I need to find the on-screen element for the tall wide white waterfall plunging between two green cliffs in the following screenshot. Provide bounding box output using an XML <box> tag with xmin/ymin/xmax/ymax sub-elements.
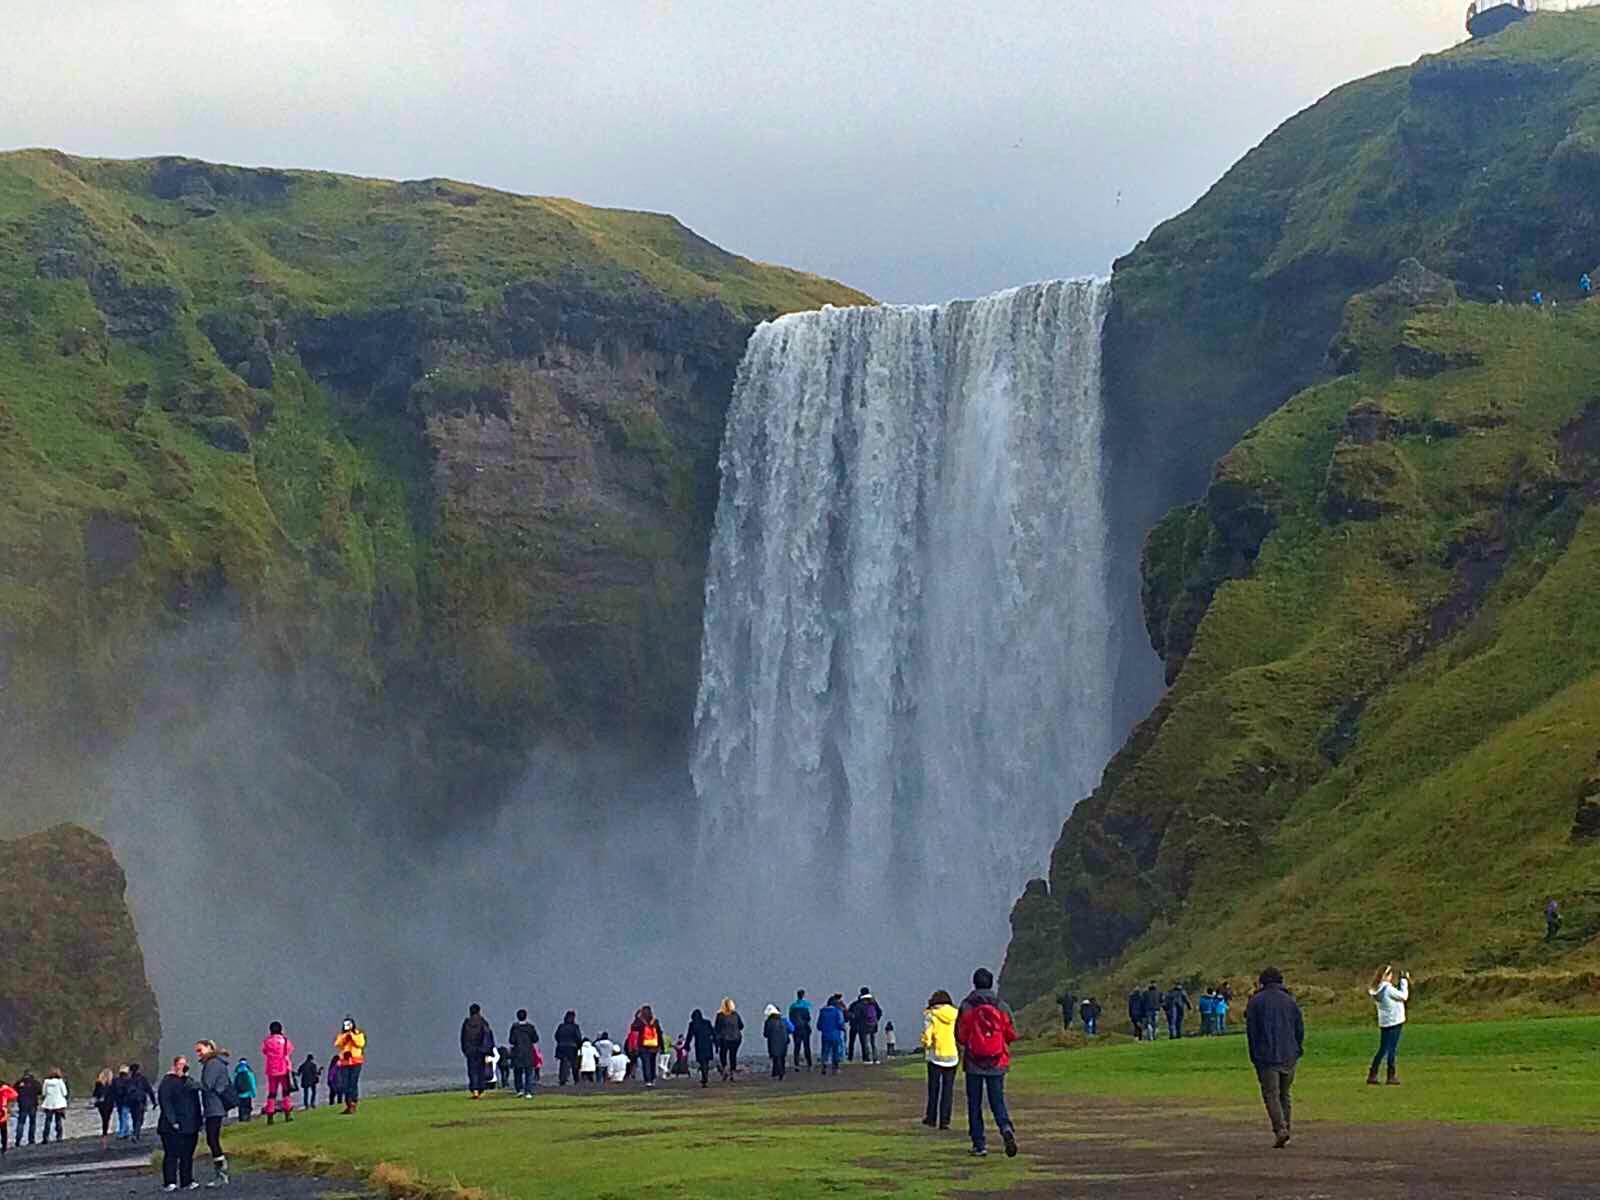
<box><xmin>693</xmin><ymin>280</ymin><xmax>1114</xmax><ymax>1005</ymax></box>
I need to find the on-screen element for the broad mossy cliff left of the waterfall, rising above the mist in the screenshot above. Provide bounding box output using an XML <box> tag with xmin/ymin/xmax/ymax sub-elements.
<box><xmin>0</xmin><ymin>150</ymin><xmax>864</xmax><ymax>824</ymax></box>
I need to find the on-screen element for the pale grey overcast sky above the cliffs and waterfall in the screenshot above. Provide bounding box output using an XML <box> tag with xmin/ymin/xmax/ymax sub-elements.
<box><xmin>0</xmin><ymin>0</ymin><xmax>1466</xmax><ymax>301</ymax></box>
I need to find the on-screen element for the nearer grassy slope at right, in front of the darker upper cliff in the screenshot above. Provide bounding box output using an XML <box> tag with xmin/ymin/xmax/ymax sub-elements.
<box><xmin>1006</xmin><ymin>264</ymin><xmax>1600</xmax><ymax>1010</ymax></box>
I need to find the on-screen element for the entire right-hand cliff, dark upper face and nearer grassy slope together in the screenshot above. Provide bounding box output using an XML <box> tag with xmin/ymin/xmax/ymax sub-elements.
<box><xmin>1006</xmin><ymin>13</ymin><xmax>1600</xmax><ymax>998</ymax></box>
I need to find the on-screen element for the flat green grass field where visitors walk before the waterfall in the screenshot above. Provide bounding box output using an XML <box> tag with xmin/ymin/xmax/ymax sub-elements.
<box><xmin>229</xmin><ymin>1018</ymin><xmax>1600</xmax><ymax>1200</ymax></box>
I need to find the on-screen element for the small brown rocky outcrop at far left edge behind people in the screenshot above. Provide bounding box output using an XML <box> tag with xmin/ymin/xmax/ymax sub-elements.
<box><xmin>0</xmin><ymin>826</ymin><xmax>162</xmax><ymax>1091</ymax></box>
